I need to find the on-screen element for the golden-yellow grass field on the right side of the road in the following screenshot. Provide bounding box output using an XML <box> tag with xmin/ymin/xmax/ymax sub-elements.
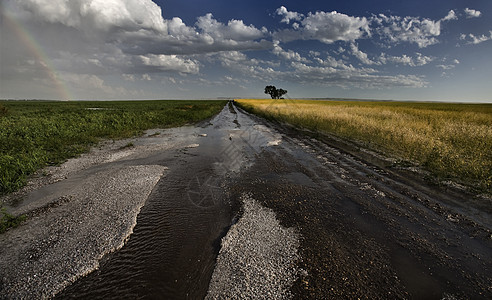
<box><xmin>236</xmin><ymin>99</ymin><xmax>492</xmax><ymax>193</ymax></box>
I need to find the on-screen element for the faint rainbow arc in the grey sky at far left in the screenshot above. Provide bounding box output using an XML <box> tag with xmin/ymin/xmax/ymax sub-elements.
<box><xmin>3</xmin><ymin>13</ymin><xmax>73</xmax><ymax>100</ymax></box>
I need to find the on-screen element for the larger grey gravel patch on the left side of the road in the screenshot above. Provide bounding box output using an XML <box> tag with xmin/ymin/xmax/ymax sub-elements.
<box><xmin>0</xmin><ymin>165</ymin><xmax>166</xmax><ymax>299</ymax></box>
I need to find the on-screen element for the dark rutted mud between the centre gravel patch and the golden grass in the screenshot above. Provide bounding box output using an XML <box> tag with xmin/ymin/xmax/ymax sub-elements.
<box><xmin>230</xmin><ymin>105</ymin><xmax>492</xmax><ymax>299</ymax></box>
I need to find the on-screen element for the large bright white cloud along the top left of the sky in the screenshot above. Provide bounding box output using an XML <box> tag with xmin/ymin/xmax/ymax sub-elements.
<box><xmin>7</xmin><ymin>0</ymin><xmax>272</xmax><ymax>55</ymax></box>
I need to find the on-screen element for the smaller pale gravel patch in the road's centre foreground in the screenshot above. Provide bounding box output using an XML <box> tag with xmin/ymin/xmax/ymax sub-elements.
<box><xmin>206</xmin><ymin>194</ymin><xmax>299</xmax><ymax>299</ymax></box>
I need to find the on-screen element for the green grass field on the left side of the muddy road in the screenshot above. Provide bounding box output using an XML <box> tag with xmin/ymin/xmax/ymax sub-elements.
<box><xmin>0</xmin><ymin>101</ymin><xmax>226</xmax><ymax>194</ymax></box>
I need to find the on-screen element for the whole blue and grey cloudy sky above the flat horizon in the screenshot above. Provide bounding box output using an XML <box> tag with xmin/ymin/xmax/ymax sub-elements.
<box><xmin>0</xmin><ymin>0</ymin><xmax>492</xmax><ymax>103</ymax></box>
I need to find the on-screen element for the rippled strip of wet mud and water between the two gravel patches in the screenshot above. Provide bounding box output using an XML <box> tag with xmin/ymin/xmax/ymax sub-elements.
<box><xmin>56</xmin><ymin>103</ymin><xmax>282</xmax><ymax>299</ymax></box>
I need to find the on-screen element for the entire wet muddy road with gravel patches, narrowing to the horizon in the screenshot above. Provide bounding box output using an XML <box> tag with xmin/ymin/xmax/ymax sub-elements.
<box><xmin>0</xmin><ymin>103</ymin><xmax>492</xmax><ymax>299</ymax></box>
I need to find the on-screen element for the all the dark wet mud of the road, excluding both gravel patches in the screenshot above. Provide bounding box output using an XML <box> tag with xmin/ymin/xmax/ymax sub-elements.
<box><xmin>0</xmin><ymin>103</ymin><xmax>492</xmax><ymax>299</ymax></box>
